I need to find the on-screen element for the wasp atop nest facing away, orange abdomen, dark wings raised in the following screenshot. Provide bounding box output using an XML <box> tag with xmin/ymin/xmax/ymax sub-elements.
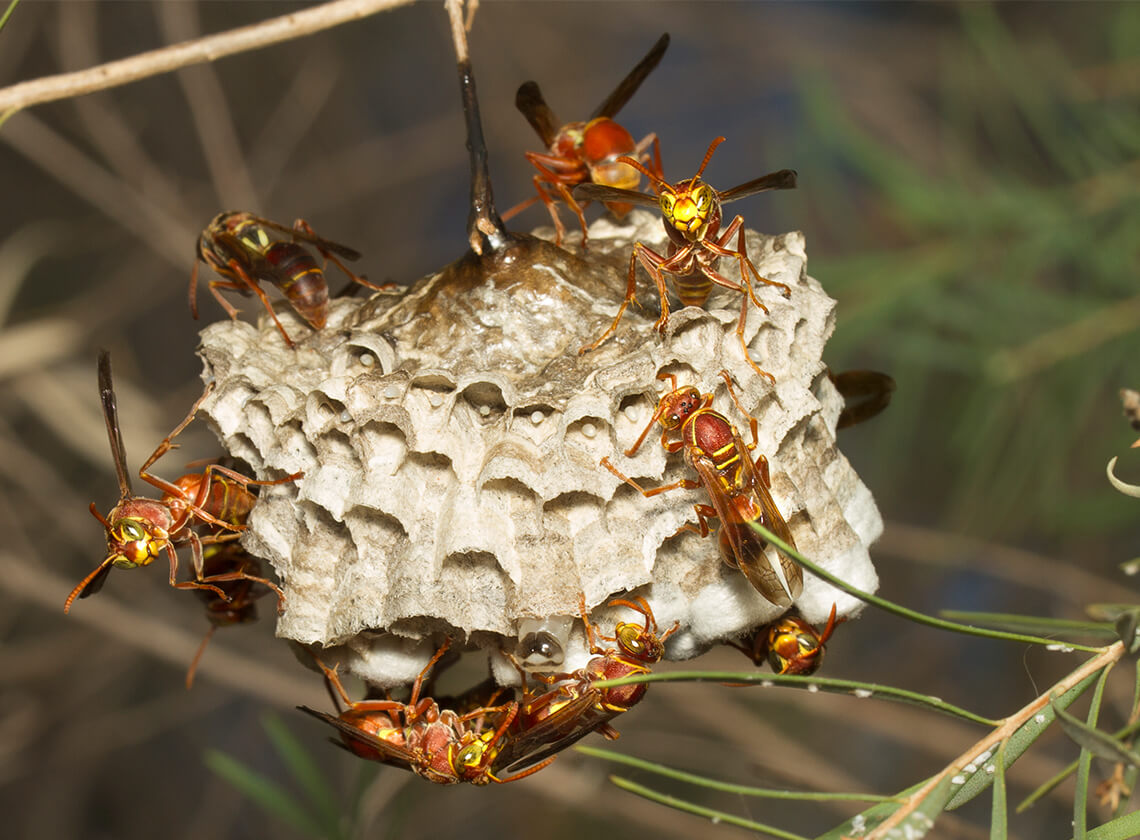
<box><xmin>503</xmin><ymin>34</ymin><xmax>669</xmax><ymax>248</ymax></box>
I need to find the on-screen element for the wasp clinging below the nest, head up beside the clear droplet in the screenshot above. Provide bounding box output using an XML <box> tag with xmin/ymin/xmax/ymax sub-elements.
<box><xmin>495</xmin><ymin>598</ymin><xmax>678</xmax><ymax>772</ymax></box>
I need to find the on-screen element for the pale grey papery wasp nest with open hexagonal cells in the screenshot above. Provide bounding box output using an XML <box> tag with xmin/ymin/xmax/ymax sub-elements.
<box><xmin>201</xmin><ymin>211</ymin><xmax>882</xmax><ymax>685</ymax></box>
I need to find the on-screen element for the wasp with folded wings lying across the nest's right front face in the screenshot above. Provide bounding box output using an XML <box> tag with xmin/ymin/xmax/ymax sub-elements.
<box><xmin>602</xmin><ymin>370</ymin><xmax>804</xmax><ymax>606</ymax></box>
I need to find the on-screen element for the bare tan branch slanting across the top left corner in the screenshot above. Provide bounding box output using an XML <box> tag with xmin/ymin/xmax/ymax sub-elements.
<box><xmin>0</xmin><ymin>0</ymin><xmax>412</xmax><ymax>114</ymax></box>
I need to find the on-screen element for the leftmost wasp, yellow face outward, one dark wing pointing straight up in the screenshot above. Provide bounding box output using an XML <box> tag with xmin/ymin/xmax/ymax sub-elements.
<box><xmin>64</xmin><ymin>351</ymin><xmax>301</xmax><ymax>612</ymax></box>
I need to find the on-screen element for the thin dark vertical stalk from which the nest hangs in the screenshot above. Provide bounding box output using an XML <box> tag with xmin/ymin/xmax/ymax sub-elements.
<box><xmin>446</xmin><ymin>0</ymin><xmax>511</xmax><ymax>255</ymax></box>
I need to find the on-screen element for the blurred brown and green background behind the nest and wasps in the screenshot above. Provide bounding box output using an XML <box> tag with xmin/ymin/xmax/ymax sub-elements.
<box><xmin>0</xmin><ymin>2</ymin><xmax>1140</xmax><ymax>840</ymax></box>
